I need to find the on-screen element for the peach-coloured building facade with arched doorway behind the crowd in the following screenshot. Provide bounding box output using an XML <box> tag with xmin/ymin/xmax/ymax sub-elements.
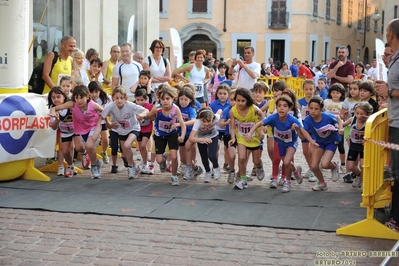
<box><xmin>159</xmin><ymin>0</ymin><xmax>393</xmax><ymax>67</ymax></box>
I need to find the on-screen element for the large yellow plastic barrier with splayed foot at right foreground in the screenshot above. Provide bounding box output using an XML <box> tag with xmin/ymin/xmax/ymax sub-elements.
<box><xmin>336</xmin><ymin>109</ymin><xmax>399</xmax><ymax>240</ymax></box>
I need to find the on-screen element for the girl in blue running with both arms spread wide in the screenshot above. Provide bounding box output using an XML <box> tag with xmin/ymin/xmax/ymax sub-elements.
<box><xmin>245</xmin><ymin>95</ymin><xmax>317</xmax><ymax>193</ymax></box>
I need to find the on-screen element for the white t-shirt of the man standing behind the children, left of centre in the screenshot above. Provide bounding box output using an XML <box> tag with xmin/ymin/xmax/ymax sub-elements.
<box><xmin>112</xmin><ymin>61</ymin><xmax>143</xmax><ymax>100</ymax></box>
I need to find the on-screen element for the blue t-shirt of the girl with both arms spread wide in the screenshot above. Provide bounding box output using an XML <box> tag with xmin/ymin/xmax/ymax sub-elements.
<box><xmin>262</xmin><ymin>113</ymin><xmax>302</xmax><ymax>147</ymax></box>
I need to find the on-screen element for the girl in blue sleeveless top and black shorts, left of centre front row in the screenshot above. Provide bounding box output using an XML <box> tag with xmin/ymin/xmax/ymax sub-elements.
<box><xmin>146</xmin><ymin>83</ymin><xmax>186</xmax><ymax>186</ymax></box>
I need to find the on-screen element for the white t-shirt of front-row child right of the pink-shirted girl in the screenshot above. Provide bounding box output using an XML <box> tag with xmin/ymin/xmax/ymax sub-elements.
<box><xmin>101</xmin><ymin>101</ymin><xmax>146</xmax><ymax>136</ymax></box>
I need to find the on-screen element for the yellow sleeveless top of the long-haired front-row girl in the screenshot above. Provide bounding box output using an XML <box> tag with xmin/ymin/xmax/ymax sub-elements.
<box><xmin>231</xmin><ymin>105</ymin><xmax>260</xmax><ymax>148</ymax></box>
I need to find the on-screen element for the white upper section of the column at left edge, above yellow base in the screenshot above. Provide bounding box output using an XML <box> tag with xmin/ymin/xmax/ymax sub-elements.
<box><xmin>0</xmin><ymin>0</ymin><xmax>31</xmax><ymax>89</ymax></box>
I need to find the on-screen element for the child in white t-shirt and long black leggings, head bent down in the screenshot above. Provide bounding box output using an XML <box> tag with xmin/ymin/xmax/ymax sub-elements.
<box><xmin>188</xmin><ymin>107</ymin><xmax>222</xmax><ymax>183</ymax></box>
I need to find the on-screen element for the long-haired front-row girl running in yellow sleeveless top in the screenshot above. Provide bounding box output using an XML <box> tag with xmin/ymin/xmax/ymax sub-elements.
<box><xmin>229</xmin><ymin>88</ymin><xmax>265</xmax><ymax>189</ymax></box>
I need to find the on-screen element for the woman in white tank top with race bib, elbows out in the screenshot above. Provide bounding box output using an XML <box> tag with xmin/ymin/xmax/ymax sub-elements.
<box><xmin>172</xmin><ymin>50</ymin><xmax>211</xmax><ymax>107</ymax></box>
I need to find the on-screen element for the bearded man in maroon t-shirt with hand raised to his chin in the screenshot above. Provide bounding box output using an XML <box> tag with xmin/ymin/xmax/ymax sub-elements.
<box><xmin>327</xmin><ymin>46</ymin><xmax>355</xmax><ymax>88</ymax></box>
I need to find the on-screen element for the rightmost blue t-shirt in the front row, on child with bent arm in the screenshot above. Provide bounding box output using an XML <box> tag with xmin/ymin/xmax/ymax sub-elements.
<box><xmin>303</xmin><ymin>112</ymin><xmax>341</xmax><ymax>144</ymax></box>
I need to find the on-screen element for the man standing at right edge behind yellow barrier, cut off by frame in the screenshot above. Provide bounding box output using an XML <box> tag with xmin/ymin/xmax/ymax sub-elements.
<box><xmin>375</xmin><ymin>19</ymin><xmax>399</xmax><ymax>232</ymax></box>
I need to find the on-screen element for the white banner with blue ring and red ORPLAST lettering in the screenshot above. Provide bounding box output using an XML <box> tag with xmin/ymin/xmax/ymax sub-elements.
<box><xmin>0</xmin><ymin>93</ymin><xmax>56</xmax><ymax>163</ymax></box>
